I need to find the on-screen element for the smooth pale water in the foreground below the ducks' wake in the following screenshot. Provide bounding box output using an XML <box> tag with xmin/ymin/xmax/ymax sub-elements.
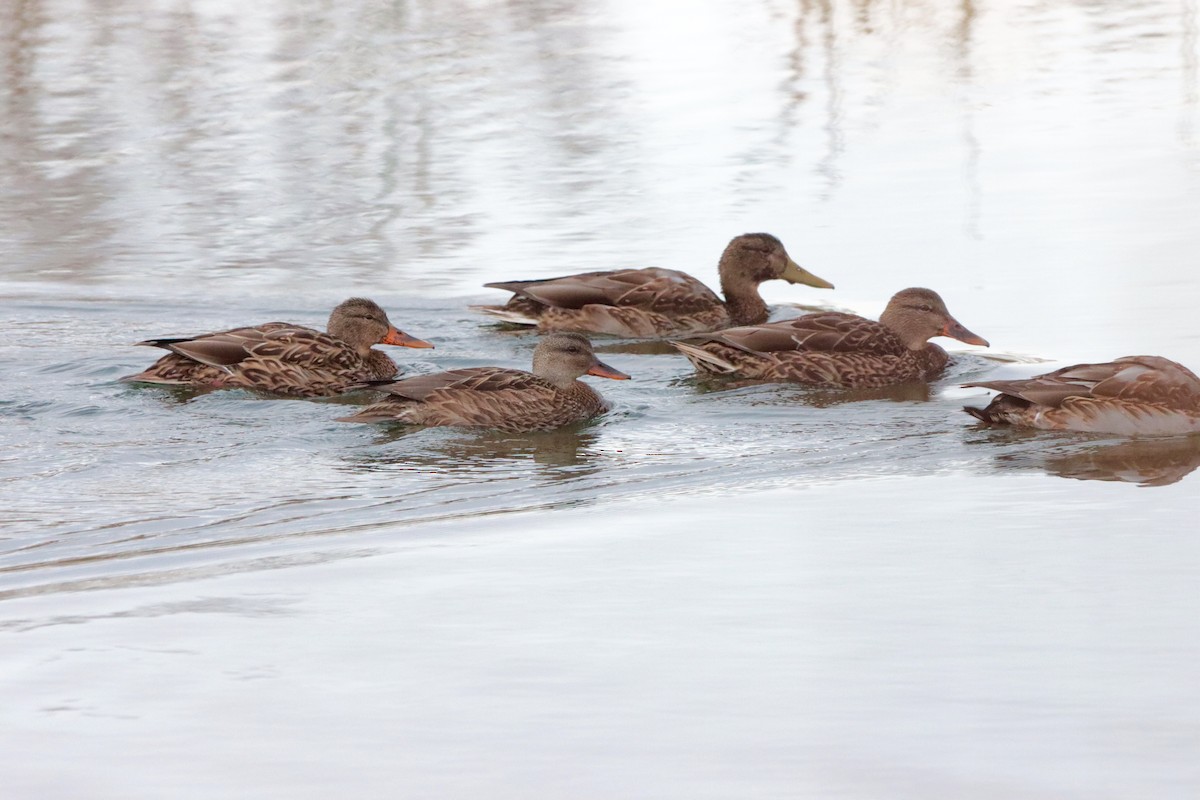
<box><xmin>7</xmin><ymin>477</ymin><xmax>1200</xmax><ymax>800</ymax></box>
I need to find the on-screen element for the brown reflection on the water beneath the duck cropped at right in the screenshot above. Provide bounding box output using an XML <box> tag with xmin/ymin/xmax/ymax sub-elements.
<box><xmin>968</xmin><ymin>429</ymin><xmax>1200</xmax><ymax>486</ymax></box>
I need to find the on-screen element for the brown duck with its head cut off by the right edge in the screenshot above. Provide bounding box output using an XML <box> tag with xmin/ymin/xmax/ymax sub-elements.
<box><xmin>962</xmin><ymin>355</ymin><xmax>1200</xmax><ymax>437</ymax></box>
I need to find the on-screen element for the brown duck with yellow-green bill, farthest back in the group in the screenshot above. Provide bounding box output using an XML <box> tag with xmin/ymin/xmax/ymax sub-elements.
<box><xmin>475</xmin><ymin>233</ymin><xmax>833</xmax><ymax>338</ymax></box>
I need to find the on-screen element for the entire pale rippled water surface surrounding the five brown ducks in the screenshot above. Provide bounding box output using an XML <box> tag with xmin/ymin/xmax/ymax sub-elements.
<box><xmin>0</xmin><ymin>0</ymin><xmax>1200</xmax><ymax>800</ymax></box>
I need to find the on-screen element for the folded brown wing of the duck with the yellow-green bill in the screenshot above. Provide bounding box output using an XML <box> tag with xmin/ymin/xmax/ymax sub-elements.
<box><xmin>485</xmin><ymin>267</ymin><xmax>721</xmax><ymax>312</ymax></box>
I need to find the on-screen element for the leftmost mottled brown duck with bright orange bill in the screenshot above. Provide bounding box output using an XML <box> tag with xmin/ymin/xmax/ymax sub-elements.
<box><xmin>121</xmin><ymin>297</ymin><xmax>433</xmax><ymax>397</ymax></box>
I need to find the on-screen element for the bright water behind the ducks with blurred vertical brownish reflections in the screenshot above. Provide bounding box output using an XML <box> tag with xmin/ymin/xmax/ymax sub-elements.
<box><xmin>7</xmin><ymin>0</ymin><xmax>1198</xmax><ymax>360</ymax></box>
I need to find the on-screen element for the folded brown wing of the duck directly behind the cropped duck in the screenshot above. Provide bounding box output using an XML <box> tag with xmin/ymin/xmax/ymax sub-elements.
<box><xmin>701</xmin><ymin>312</ymin><xmax>905</xmax><ymax>356</ymax></box>
